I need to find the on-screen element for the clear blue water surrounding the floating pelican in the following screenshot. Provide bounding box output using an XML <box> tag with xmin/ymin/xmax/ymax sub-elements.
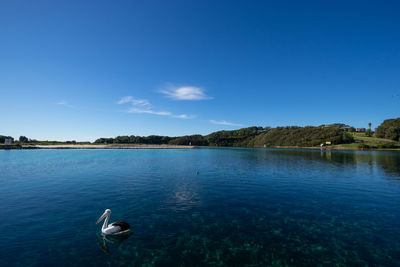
<box><xmin>0</xmin><ymin>148</ymin><xmax>400</xmax><ymax>266</ymax></box>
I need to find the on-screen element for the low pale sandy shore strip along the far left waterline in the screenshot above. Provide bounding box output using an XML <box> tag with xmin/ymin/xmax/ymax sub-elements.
<box><xmin>22</xmin><ymin>144</ymin><xmax>195</xmax><ymax>149</ymax></box>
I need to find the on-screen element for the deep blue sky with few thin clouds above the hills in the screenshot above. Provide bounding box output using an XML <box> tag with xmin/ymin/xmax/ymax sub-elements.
<box><xmin>0</xmin><ymin>0</ymin><xmax>400</xmax><ymax>141</ymax></box>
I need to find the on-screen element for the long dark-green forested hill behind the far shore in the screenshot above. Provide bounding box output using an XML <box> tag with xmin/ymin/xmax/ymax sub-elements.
<box><xmin>95</xmin><ymin>126</ymin><xmax>354</xmax><ymax>147</ymax></box>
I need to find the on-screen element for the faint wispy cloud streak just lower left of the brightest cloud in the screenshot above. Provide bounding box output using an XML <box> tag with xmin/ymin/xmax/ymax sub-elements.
<box><xmin>117</xmin><ymin>96</ymin><xmax>195</xmax><ymax>119</ymax></box>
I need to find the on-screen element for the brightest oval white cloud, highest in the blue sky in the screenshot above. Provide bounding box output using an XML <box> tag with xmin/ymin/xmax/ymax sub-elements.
<box><xmin>160</xmin><ymin>86</ymin><xmax>212</xmax><ymax>100</ymax></box>
